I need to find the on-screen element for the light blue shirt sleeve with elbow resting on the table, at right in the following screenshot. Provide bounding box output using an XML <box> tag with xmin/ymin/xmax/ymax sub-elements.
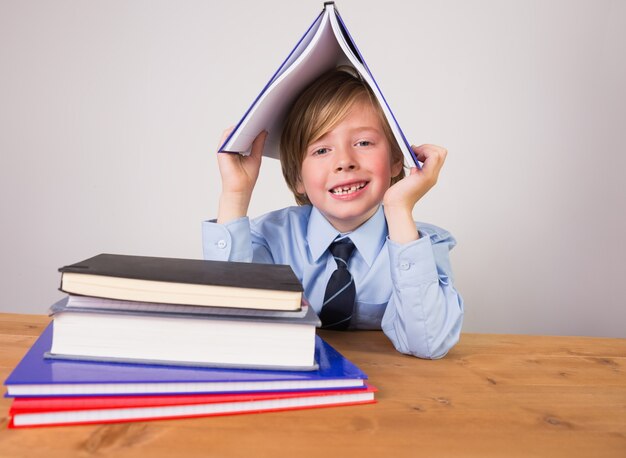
<box><xmin>382</xmin><ymin>231</ymin><xmax>463</xmax><ymax>359</ymax></box>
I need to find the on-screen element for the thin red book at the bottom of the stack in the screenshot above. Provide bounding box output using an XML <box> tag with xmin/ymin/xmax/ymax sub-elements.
<box><xmin>9</xmin><ymin>385</ymin><xmax>376</xmax><ymax>428</ymax></box>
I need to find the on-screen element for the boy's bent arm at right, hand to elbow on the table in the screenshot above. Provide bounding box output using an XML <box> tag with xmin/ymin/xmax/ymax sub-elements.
<box><xmin>382</xmin><ymin>145</ymin><xmax>463</xmax><ymax>358</ymax></box>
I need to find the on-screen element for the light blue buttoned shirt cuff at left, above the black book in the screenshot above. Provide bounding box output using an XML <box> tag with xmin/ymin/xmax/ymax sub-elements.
<box><xmin>202</xmin><ymin>217</ymin><xmax>252</xmax><ymax>262</ymax></box>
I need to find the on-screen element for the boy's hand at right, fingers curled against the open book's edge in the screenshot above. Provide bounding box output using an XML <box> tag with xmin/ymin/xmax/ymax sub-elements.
<box><xmin>383</xmin><ymin>145</ymin><xmax>448</xmax><ymax>211</ymax></box>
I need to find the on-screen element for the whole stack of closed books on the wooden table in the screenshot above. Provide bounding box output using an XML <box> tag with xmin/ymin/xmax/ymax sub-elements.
<box><xmin>5</xmin><ymin>255</ymin><xmax>375</xmax><ymax>428</ymax></box>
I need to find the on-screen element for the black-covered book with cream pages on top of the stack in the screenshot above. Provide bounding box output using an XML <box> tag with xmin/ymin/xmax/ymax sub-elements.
<box><xmin>59</xmin><ymin>254</ymin><xmax>303</xmax><ymax>310</ymax></box>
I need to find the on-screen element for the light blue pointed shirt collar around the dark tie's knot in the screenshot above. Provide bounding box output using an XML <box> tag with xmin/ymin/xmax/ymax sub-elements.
<box><xmin>306</xmin><ymin>205</ymin><xmax>387</xmax><ymax>267</ymax></box>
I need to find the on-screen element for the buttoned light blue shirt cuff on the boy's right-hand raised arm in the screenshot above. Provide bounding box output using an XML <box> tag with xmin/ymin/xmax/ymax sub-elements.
<box><xmin>387</xmin><ymin>233</ymin><xmax>439</xmax><ymax>287</ymax></box>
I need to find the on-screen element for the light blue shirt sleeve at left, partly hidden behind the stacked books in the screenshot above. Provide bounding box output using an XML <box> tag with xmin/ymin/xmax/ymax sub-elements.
<box><xmin>202</xmin><ymin>217</ymin><xmax>273</xmax><ymax>263</ymax></box>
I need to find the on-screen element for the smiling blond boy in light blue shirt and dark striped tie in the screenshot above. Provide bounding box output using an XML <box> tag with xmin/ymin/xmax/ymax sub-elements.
<box><xmin>203</xmin><ymin>68</ymin><xmax>463</xmax><ymax>358</ymax></box>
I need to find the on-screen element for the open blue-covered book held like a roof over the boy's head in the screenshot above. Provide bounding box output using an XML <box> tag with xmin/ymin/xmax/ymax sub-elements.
<box><xmin>219</xmin><ymin>2</ymin><xmax>418</xmax><ymax>167</ymax></box>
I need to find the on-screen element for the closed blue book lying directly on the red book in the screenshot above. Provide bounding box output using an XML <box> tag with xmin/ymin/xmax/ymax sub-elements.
<box><xmin>4</xmin><ymin>323</ymin><xmax>367</xmax><ymax>397</ymax></box>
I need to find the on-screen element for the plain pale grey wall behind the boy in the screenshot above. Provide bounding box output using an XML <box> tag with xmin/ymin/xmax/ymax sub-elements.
<box><xmin>0</xmin><ymin>0</ymin><xmax>626</xmax><ymax>337</ymax></box>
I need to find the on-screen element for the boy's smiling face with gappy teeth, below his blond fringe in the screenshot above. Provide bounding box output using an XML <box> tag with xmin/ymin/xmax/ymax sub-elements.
<box><xmin>296</xmin><ymin>101</ymin><xmax>402</xmax><ymax>232</ymax></box>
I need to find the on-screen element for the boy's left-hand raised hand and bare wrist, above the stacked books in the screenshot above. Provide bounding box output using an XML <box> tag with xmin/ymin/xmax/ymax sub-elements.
<box><xmin>217</xmin><ymin>128</ymin><xmax>267</xmax><ymax>224</ymax></box>
